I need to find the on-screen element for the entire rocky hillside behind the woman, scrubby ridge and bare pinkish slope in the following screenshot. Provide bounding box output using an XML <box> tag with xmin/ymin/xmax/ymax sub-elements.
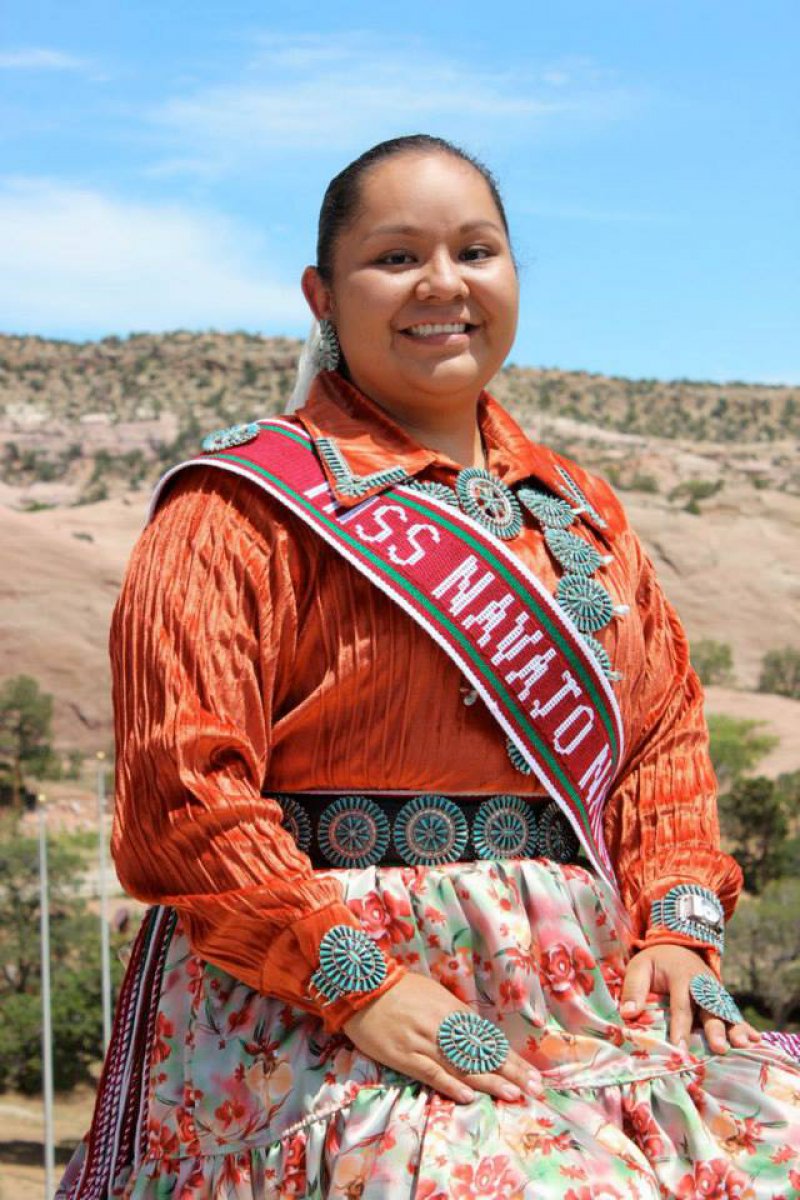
<box><xmin>0</xmin><ymin>334</ymin><xmax>800</xmax><ymax>769</ymax></box>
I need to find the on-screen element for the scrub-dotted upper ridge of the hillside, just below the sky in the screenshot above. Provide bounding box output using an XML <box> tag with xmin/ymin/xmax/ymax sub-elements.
<box><xmin>0</xmin><ymin>332</ymin><xmax>800</xmax><ymax>508</ymax></box>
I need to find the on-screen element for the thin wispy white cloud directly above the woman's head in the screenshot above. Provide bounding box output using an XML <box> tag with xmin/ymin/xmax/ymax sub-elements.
<box><xmin>152</xmin><ymin>32</ymin><xmax>633</xmax><ymax>163</ymax></box>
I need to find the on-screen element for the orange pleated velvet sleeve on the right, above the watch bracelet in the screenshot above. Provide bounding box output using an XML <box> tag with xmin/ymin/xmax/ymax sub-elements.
<box><xmin>604</xmin><ymin>528</ymin><xmax>741</xmax><ymax>970</ymax></box>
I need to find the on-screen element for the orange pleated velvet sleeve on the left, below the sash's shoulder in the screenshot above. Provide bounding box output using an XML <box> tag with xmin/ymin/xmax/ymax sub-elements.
<box><xmin>110</xmin><ymin>467</ymin><xmax>404</xmax><ymax>1031</ymax></box>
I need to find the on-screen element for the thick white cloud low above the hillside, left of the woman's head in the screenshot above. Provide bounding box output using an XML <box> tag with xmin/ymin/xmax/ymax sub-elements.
<box><xmin>0</xmin><ymin>179</ymin><xmax>306</xmax><ymax>336</ymax></box>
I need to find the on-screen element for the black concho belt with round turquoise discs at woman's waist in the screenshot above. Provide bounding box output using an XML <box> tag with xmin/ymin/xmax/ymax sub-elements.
<box><xmin>275</xmin><ymin>792</ymin><xmax>581</xmax><ymax>870</ymax></box>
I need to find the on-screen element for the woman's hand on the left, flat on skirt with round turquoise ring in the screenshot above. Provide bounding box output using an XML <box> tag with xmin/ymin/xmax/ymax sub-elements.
<box><xmin>343</xmin><ymin>972</ymin><xmax>541</xmax><ymax>1104</ymax></box>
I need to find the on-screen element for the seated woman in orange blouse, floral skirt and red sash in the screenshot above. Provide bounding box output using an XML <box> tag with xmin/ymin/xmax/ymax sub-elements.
<box><xmin>60</xmin><ymin>136</ymin><xmax>800</xmax><ymax>1200</ymax></box>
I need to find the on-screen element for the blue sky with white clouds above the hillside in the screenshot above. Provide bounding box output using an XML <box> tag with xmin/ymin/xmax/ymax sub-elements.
<box><xmin>0</xmin><ymin>0</ymin><xmax>800</xmax><ymax>383</ymax></box>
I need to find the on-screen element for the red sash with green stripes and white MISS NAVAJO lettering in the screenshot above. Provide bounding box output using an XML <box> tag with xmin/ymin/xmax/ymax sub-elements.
<box><xmin>150</xmin><ymin>418</ymin><xmax>624</xmax><ymax>886</ymax></box>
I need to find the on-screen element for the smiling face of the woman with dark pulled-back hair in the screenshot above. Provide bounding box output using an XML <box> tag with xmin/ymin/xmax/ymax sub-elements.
<box><xmin>303</xmin><ymin>152</ymin><xmax>519</xmax><ymax>422</ymax></box>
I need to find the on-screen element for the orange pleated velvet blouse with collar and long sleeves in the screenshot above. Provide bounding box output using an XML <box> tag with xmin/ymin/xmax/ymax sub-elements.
<box><xmin>110</xmin><ymin>373</ymin><xmax>741</xmax><ymax>1030</ymax></box>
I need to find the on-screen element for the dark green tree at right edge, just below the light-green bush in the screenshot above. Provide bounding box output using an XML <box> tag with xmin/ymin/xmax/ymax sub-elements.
<box><xmin>720</xmin><ymin>775</ymin><xmax>792</xmax><ymax>893</ymax></box>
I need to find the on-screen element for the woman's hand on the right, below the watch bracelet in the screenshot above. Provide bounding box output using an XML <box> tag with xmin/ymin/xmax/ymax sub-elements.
<box><xmin>620</xmin><ymin>946</ymin><xmax>762</xmax><ymax>1054</ymax></box>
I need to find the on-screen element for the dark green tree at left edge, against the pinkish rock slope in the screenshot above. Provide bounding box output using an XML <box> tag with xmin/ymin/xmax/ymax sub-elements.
<box><xmin>0</xmin><ymin>674</ymin><xmax>53</xmax><ymax>809</ymax></box>
